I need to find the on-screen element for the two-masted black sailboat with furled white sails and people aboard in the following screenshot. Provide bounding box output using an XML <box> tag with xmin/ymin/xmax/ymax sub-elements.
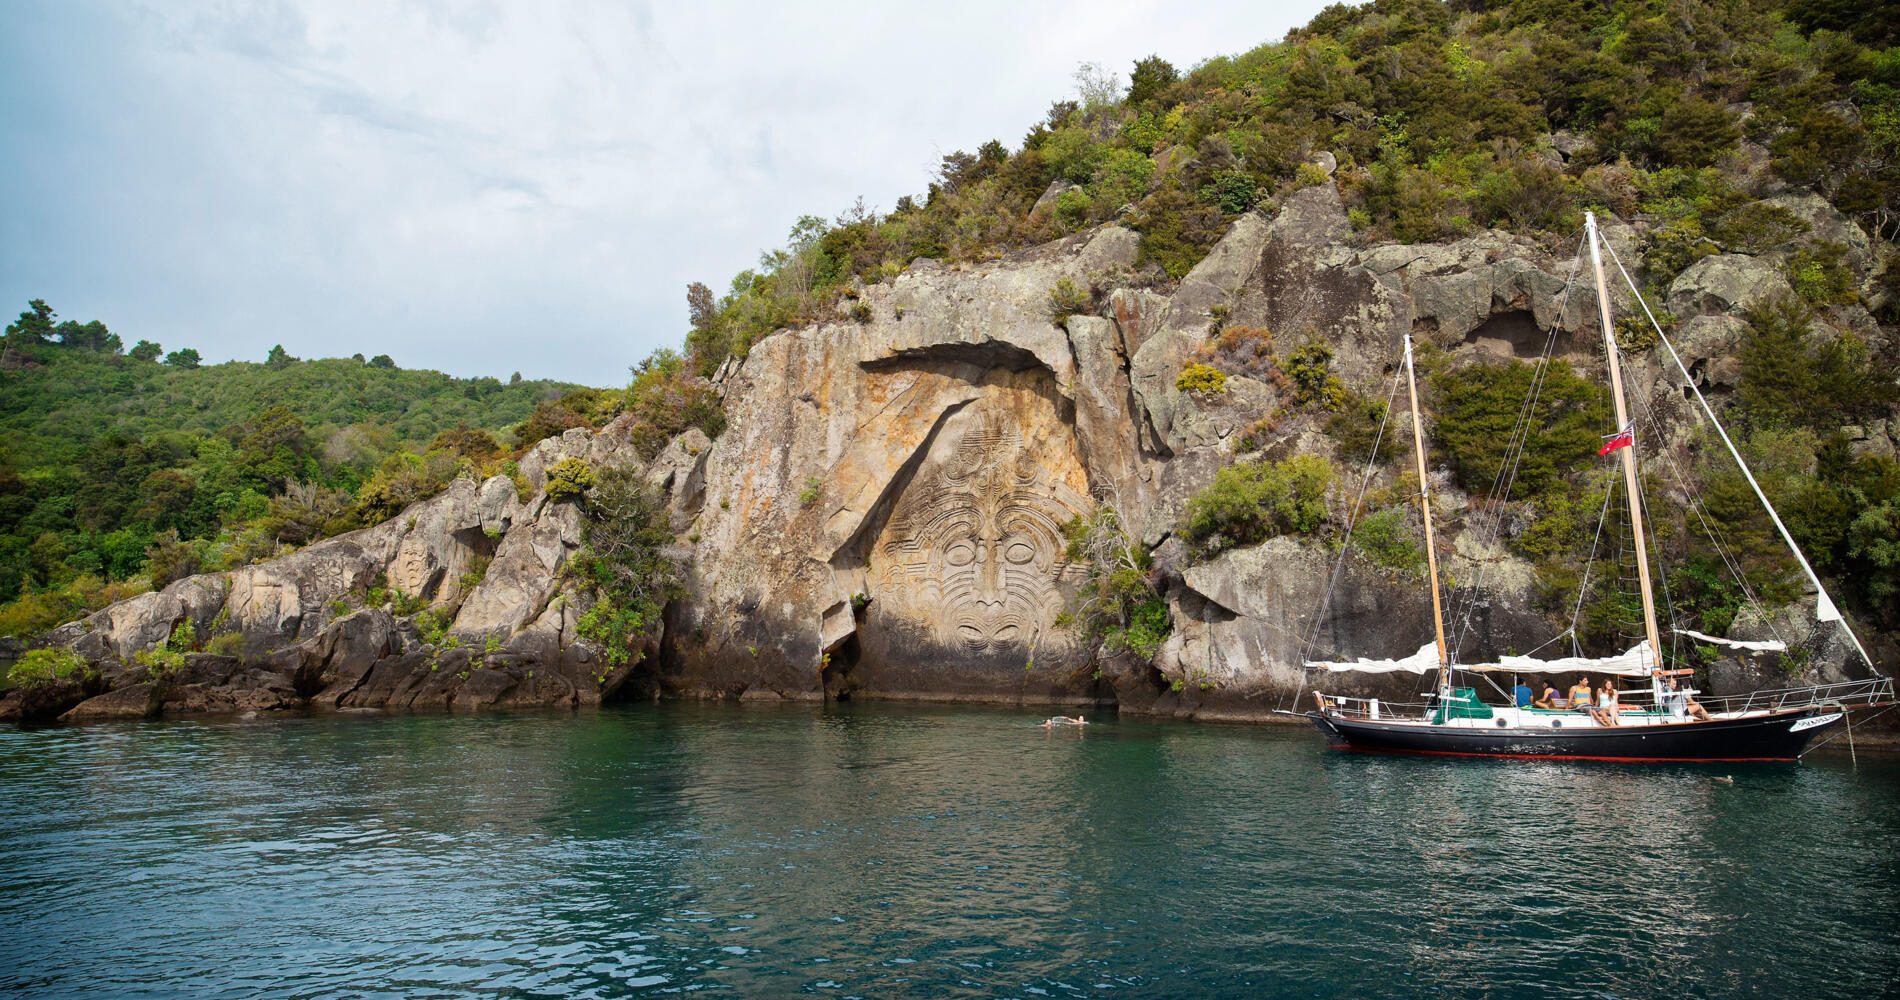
<box><xmin>1288</xmin><ymin>213</ymin><xmax>1894</xmax><ymax>760</ymax></box>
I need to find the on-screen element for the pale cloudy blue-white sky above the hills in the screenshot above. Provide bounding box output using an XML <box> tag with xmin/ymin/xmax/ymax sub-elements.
<box><xmin>0</xmin><ymin>0</ymin><xmax>1322</xmax><ymax>386</ymax></box>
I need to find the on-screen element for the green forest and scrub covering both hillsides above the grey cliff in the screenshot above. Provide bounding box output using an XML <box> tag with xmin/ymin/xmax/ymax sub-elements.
<box><xmin>0</xmin><ymin>0</ymin><xmax>1900</xmax><ymax>650</ymax></box>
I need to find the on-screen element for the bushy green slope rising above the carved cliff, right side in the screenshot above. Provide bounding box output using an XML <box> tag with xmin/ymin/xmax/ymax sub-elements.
<box><xmin>665</xmin><ymin>0</ymin><xmax>1900</xmax><ymax>648</ymax></box>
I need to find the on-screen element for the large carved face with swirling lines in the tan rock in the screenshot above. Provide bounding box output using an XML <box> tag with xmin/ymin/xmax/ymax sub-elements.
<box><xmin>876</xmin><ymin>420</ymin><xmax>1077</xmax><ymax>654</ymax></box>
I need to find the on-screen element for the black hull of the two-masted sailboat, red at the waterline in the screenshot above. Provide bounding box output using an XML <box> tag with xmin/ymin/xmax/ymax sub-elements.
<box><xmin>1305</xmin><ymin>707</ymin><xmax>1841</xmax><ymax>760</ymax></box>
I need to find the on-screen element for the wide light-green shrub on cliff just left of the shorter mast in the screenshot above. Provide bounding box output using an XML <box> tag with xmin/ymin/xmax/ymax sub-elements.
<box><xmin>1182</xmin><ymin>454</ymin><xmax>1334</xmax><ymax>557</ymax></box>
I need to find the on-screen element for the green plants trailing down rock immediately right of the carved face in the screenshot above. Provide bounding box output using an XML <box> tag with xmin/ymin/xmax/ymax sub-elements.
<box><xmin>1056</xmin><ymin>504</ymin><xmax>1172</xmax><ymax>662</ymax></box>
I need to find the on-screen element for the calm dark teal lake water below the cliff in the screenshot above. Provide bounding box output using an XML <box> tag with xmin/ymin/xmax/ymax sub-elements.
<box><xmin>0</xmin><ymin>705</ymin><xmax>1900</xmax><ymax>998</ymax></box>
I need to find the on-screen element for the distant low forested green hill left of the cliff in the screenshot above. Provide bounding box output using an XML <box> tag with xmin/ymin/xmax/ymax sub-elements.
<box><xmin>0</xmin><ymin>300</ymin><xmax>585</xmax><ymax>633</ymax></box>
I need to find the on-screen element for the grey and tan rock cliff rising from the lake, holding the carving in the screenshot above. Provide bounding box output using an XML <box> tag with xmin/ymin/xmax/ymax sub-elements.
<box><xmin>0</xmin><ymin>184</ymin><xmax>1894</xmax><ymax>719</ymax></box>
